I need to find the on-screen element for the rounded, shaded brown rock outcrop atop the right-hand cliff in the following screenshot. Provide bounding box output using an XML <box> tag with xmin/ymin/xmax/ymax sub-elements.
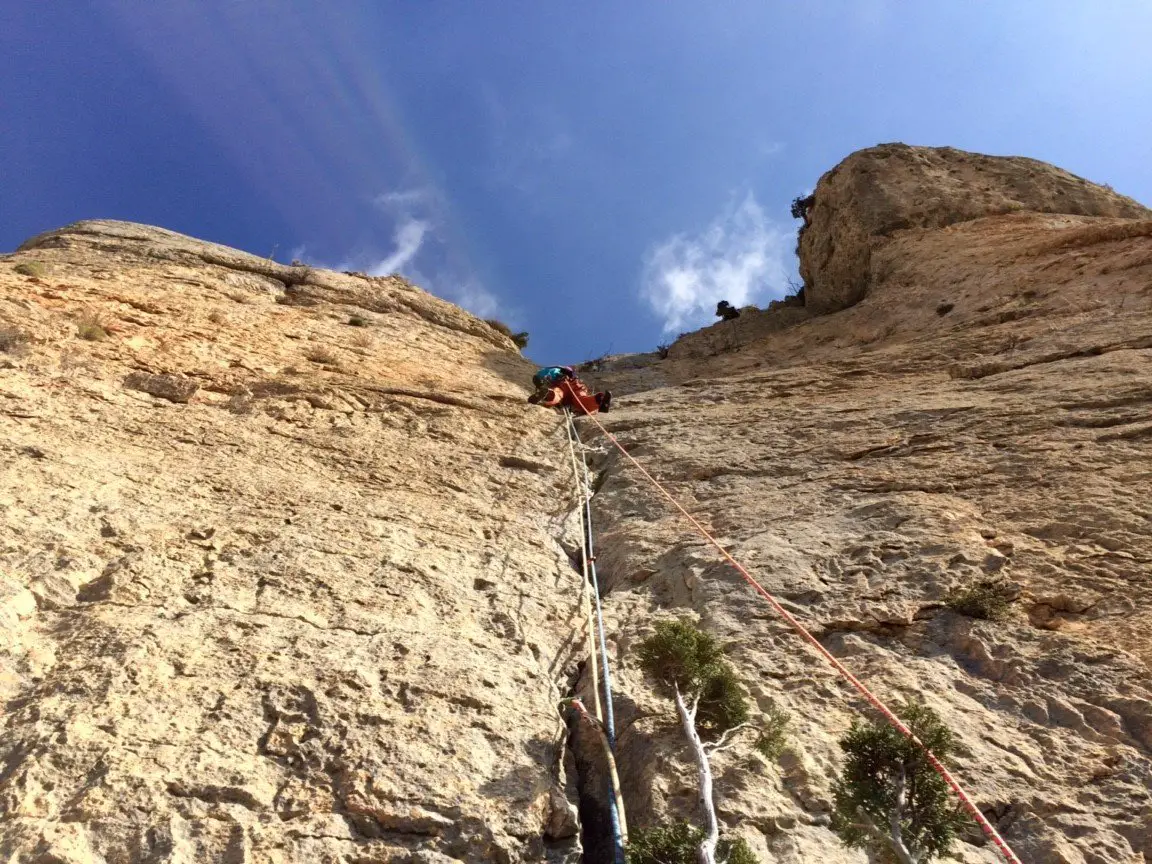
<box><xmin>799</xmin><ymin>144</ymin><xmax>1152</xmax><ymax>314</ymax></box>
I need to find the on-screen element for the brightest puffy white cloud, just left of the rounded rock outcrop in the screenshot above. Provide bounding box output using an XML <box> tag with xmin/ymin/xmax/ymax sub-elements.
<box><xmin>641</xmin><ymin>192</ymin><xmax>794</xmax><ymax>333</ymax></box>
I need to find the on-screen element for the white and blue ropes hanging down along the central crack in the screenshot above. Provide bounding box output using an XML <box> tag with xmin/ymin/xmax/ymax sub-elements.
<box><xmin>564</xmin><ymin>408</ymin><xmax>628</xmax><ymax>864</ymax></box>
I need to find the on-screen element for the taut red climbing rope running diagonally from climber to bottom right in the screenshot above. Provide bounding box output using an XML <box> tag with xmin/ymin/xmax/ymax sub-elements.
<box><xmin>585</xmin><ymin>414</ymin><xmax>1021</xmax><ymax>864</ymax></box>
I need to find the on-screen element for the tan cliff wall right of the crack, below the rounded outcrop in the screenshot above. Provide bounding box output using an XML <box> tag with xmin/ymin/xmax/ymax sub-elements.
<box><xmin>580</xmin><ymin>157</ymin><xmax>1152</xmax><ymax>864</ymax></box>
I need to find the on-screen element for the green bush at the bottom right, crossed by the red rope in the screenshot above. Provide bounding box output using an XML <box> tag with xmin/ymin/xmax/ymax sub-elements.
<box><xmin>832</xmin><ymin>703</ymin><xmax>968</xmax><ymax>864</ymax></box>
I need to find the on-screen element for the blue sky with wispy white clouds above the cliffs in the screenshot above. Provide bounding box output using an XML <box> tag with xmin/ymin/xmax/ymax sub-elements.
<box><xmin>0</xmin><ymin>0</ymin><xmax>1152</xmax><ymax>363</ymax></box>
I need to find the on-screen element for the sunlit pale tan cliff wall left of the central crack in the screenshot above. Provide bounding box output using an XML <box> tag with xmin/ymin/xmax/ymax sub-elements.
<box><xmin>0</xmin><ymin>222</ymin><xmax>578</xmax><ymax>864</ymax></box>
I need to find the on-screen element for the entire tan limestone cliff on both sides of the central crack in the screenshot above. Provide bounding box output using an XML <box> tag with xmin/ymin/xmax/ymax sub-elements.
<box><xmin>0</xmin><ymin>138</ymin><xmax>1152</xmax><ymax>864</ymax></box>
